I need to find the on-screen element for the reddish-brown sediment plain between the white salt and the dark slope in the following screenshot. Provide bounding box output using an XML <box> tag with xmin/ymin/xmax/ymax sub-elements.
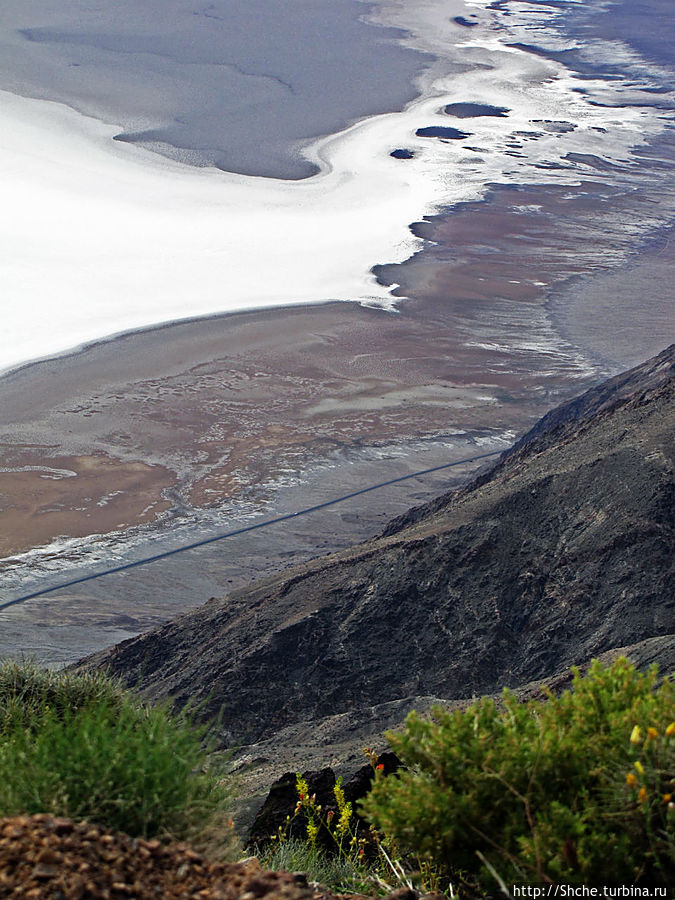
<box><xmin>0</xmin><ymin>149</ymin><xmax>675</xmax><ymax>557</ymax></box>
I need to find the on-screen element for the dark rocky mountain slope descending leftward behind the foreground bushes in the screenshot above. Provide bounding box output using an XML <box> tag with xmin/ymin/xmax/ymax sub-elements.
<box><xmin>83</xmin><ymin>345</ymin><xmax>675</xmax><ymax>771</ymax></box>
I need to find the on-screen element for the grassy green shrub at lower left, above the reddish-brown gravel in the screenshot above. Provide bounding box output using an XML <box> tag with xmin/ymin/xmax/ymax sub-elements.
<box><xmin>0</xmin><ymin>663</ymin><xmax>234</xmax><ymax>838</ymax></box>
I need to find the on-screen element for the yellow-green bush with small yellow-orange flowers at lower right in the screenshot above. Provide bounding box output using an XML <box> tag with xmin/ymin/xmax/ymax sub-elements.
<box><xmin>363</xmin><ymin>659</ymin><xmax>675</xmax><ymax>888</ymax></box>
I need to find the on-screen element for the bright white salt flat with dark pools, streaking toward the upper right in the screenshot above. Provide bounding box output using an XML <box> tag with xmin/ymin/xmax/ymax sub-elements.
<box><xmin>0</xmin><ymin>0</ymin><xmax>664</xmax><ymax>370</ymax></box>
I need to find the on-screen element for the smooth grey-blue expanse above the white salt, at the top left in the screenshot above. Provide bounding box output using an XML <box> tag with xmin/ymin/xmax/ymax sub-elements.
<box><xmin>0</xmin><ymin>0</ymin><xmax>425</xmax><ymax>178</ymax></box>
